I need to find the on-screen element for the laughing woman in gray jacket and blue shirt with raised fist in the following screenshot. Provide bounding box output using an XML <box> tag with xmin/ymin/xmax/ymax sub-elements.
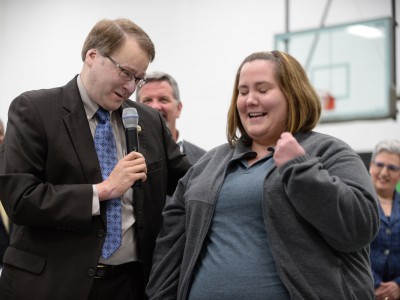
<box><xmin>147</xmin><ymin>51</ymin><xmax>379</xmax><ymax>300</ymax></box>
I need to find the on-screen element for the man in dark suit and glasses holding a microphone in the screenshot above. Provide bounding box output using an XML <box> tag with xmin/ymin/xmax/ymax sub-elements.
<box><xmin>0</xmin><ymin>19</ymin><xmax>190</xmax><ymax>300</ymax></box>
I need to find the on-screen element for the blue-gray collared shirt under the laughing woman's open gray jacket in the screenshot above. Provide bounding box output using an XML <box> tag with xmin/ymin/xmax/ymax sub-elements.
<box><xmin>188</xmin><ymin>155</ymin><xmax>290</xmax><ymax>300</ymax></box>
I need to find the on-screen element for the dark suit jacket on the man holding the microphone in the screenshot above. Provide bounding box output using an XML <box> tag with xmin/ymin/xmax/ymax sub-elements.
<box><xmin>0</xmin><ymin>77</ymin><xmax>190</xmax><ymax>300</ymax></box>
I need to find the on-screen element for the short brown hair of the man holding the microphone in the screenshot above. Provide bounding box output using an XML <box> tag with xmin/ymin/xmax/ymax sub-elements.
<box><xmin>81</xmin><ymin>18</ymin><xmax>155</xmax><ymax>62</ymax></box>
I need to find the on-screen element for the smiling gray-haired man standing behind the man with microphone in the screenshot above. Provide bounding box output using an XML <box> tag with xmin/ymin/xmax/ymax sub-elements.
<box><xmin>136</xmin><ymin>72</ymin><xmax>206</xmax><ymax>164</ymax></box>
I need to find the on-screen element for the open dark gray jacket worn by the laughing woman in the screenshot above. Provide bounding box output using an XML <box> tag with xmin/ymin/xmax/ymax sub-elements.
<box><xmin>147</xmin><ymin>132</ymin><xmax>379</xmax><ymax>300</ymax></box>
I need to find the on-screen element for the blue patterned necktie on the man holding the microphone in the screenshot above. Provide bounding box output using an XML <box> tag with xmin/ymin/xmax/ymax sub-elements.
<box><xmin>94</xmin><ymin>107</ymin><xmax>122</xmax><ymax>259</ymax></box>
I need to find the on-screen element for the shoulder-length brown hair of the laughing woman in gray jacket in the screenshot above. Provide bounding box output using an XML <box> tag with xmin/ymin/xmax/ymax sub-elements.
<box><xmin>227</xmin><ymin>51</ymin><xmax>321</xmax><ymax>145</ymax></box>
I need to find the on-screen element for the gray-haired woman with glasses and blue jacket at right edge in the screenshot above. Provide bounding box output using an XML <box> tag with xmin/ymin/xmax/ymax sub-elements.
<box><xmin>369</xmin><ymin>140</ymin><xmax>400</xmax><ymax>300</ymax></box>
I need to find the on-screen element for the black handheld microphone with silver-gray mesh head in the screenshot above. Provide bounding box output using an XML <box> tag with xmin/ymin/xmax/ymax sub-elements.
<box><xmin>122</xmin><ymin>107</ymin><xmax>141</xmax><ymax>187</ymax></box>
